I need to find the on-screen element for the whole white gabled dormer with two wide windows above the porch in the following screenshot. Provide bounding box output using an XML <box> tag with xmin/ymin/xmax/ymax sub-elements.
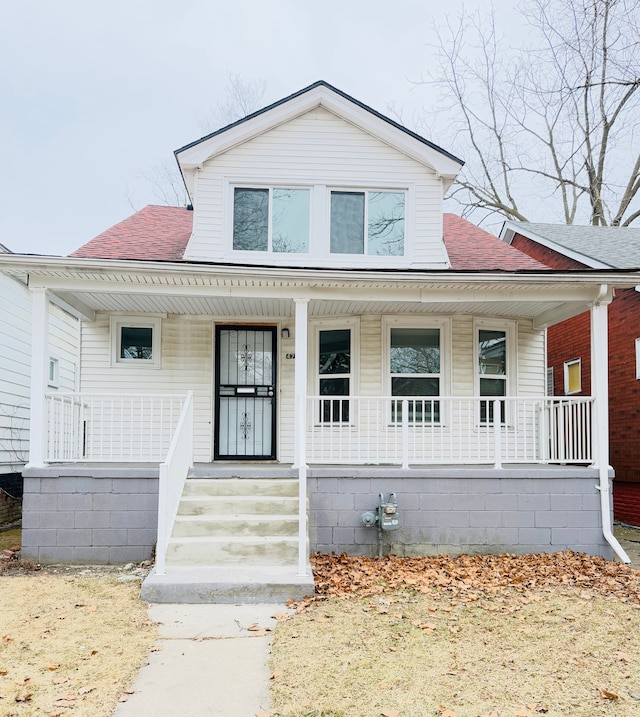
<box><xmin>175</xmin><ymin>82</ymin><xmax>462</xmax><ymax>269</ymax></box>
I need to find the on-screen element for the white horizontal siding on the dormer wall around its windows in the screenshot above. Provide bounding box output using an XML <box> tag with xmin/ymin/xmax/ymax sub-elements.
<box><xmin>185</xmin><ymin>108</ymin><xmax>446</xmax><ymax>267</ymax></box>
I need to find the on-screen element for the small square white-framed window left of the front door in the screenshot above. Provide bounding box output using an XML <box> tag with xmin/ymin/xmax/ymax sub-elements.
<box><xmin>111</xmin><ymin>317</ymin><xmax>160</xmax><ymax>367</ymax></box>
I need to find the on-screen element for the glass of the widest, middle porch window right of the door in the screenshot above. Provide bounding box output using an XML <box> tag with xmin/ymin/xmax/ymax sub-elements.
<box><xmin>389</xmin><ymin>328</ymin><xmax>440</xmax><ymax>423</ymax></box>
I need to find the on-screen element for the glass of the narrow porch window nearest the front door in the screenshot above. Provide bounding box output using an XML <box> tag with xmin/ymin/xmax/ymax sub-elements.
<box><xmin>318</xmin><ymin>329</ymin><xmax>352</xmax><ymax>423</ymax></box>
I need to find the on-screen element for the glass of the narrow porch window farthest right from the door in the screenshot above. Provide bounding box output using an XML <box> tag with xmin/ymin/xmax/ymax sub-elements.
<box><xmin>477</xmin><ymin>329</ymin><xmax>507</xmax><ymax>423</ymax></box>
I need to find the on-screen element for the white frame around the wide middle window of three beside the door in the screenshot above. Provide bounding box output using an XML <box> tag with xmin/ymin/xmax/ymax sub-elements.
<box><xmin>382</xmin><ymin>316</ymin><xmax>452</xmax><ymax>426</ymax></box>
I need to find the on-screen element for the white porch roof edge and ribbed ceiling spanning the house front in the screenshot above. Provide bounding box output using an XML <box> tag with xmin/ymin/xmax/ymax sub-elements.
<box><xmin>0</xmin><ymin>254</ymin><xmax>640</xmax><ymax>327</ymax></box>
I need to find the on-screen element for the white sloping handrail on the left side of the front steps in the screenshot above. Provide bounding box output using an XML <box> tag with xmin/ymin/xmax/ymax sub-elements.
<box><xmin>156</xmin><ymin>391</ymin><xmax>193</xmax><ymax>575</ymax></box>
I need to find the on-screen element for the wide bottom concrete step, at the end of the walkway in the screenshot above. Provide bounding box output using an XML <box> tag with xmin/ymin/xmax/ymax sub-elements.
<box><xmin>140</xmin><ymin>565</ymin><xmax>314</xmax><ymax>604</ymax></box>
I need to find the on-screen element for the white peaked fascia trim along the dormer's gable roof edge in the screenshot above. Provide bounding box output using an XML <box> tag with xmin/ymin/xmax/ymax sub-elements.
<box><xmin>176</xmin><ymin>86</ymin><xmax>462</xmax><ymax>182</ymax></box>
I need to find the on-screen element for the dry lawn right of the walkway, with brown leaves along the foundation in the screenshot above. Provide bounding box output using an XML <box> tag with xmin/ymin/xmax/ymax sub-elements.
<box><xmin>270</xmin><ymin>552</ymin><xmax>640</xmax><ymax>717</ymax></box>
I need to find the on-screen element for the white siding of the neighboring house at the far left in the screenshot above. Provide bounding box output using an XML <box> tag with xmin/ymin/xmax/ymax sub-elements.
<box><xmin>0</xmin><ymin>274</ymin><xmax>79</xmax><ymax>473</ymax></box>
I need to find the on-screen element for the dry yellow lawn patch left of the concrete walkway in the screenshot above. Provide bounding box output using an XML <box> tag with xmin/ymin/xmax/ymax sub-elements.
<box><xmin>0</xmin><ymin>567</ymin><xmax>156</xmax><ymax>717</ymax></box>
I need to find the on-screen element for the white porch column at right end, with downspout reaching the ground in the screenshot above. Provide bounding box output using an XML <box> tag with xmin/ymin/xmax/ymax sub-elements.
<box><xmin>591</xmin><ymin>284</ymin><xmax>631</xmax><ymax>563</ymax></box>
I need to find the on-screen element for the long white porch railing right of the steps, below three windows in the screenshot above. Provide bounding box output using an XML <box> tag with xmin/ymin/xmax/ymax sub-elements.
<box><xmin>306</xmin><ymin>396</ymin><xmax>593</xmax><ymax>468</ymax></box>
